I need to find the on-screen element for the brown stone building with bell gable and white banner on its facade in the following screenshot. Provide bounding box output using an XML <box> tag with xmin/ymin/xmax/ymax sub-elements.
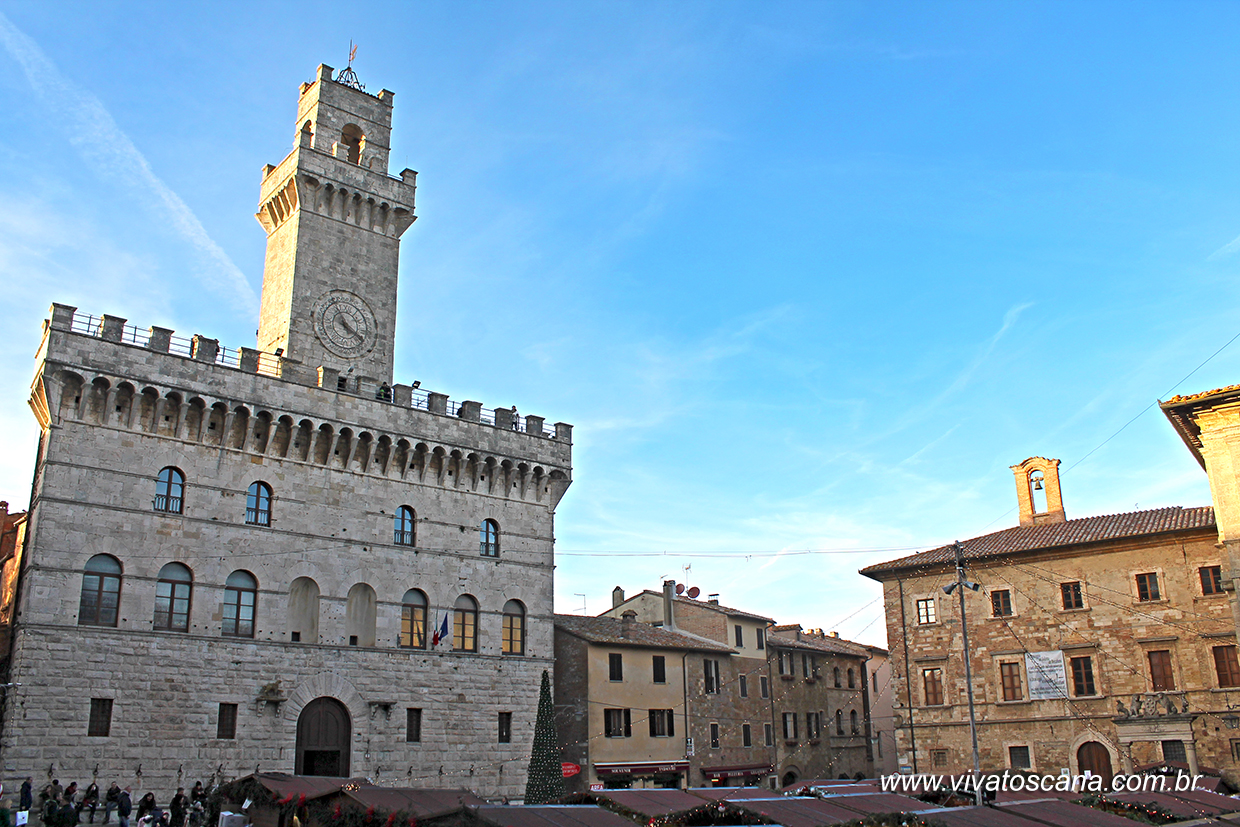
<box><xmin>863</xmin><ymin>460</ymin><xmax>1240</xmax><ymax>781</ymax></box>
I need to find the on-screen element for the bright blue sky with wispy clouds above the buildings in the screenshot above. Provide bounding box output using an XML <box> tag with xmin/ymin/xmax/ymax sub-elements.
<box><xmin>0</xmin><ymin>2</ymin><xmax>1240</xmax><ymax>642</ymax></box>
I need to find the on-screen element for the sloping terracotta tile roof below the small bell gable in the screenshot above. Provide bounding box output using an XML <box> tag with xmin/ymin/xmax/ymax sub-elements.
<box><xmin>861</xmin><ymin>506</ymin><xmax>1214</xmax><ymax>580</ymax></box>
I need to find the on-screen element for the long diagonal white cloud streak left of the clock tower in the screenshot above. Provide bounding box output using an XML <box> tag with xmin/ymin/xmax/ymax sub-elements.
<box><xmin>0</xmin><ymin>12</ymin><xmax>258</xmax><ymax>314</ymax></box>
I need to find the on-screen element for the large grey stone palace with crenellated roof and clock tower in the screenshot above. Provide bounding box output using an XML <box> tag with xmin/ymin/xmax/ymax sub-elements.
<box><xmin>0</xmin><ymin>66</ymin><xmax>572</xmax><ymax>801</ymax></box>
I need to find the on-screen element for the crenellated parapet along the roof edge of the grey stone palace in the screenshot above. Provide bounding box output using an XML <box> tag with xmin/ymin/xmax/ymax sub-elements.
<box><xmin>36</xmin><ymin>304</ymin><xmax>573</xmax><ymax>471</ymax></box>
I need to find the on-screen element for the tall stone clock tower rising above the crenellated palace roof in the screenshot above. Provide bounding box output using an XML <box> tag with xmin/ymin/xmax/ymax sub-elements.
<box><xmin>257</xmin><ymin>66</ymin><xmax>418</xmax><ymax>392</ymax></box>
